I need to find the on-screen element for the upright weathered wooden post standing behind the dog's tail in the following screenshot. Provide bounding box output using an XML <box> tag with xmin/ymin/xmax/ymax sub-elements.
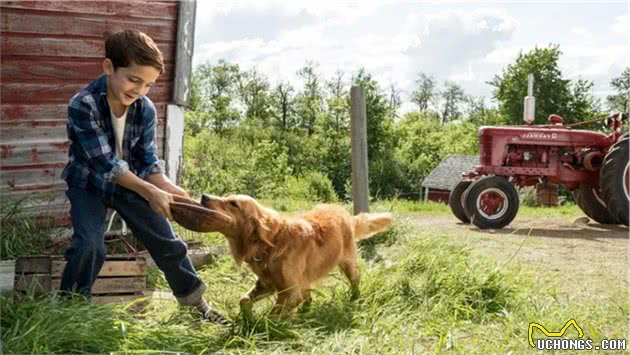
<box><xmin>350</xmin><ymin>86</ymin><xmax>370</xmax><ymax>215</ymax></box>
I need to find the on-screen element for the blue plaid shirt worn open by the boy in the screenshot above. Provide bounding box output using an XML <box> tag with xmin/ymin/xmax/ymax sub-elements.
<box><xmin>61</xmin><ymin>75</ymin><xmax>164</xmax><ymax>201</ymax></box>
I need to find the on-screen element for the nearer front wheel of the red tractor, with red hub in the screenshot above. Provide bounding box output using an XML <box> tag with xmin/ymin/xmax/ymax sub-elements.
<box><xmin>465</xmin><ymin>176</ymin><xmax>519</xmax><ymax>229</ymax></box>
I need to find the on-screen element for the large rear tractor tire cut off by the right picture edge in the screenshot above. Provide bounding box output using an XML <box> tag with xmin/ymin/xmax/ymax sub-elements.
<box><xmin>599</xmin><ymin>133</ymin><xmax>630</xmax><ymax>226</ymax></box>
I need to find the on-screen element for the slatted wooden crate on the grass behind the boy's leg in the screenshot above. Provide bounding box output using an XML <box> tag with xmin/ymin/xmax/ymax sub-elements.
<box><xmin>15</xmin><ymin>255</ymin><xmax>147</xmax><ymax>303</ymax></box>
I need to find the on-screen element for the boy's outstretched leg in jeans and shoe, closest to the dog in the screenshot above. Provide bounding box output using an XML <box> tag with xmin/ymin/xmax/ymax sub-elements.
<box><xmin>113</xmin><ymin>186</ymin><xmax>224</xmax><ymax>323</ymax></box>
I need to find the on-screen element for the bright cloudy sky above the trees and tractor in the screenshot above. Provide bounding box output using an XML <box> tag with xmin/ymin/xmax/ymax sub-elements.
<box><xmin>193</xmin><ymin>0</ymin><xmax>630</xmax><ymax>112</ymax></box>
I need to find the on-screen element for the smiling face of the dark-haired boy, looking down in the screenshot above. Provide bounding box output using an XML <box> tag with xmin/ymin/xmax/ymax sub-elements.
<box><xmin>103</xmin><ymin>59</ymin><xmax>160</xmax><ymax>107</ymax></box>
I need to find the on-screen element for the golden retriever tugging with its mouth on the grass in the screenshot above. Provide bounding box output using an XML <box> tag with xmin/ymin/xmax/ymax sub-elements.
<box><xmin>171</xmin><ymin>195</ymin><xmax>392</xmax><ymax>314</ymax></box>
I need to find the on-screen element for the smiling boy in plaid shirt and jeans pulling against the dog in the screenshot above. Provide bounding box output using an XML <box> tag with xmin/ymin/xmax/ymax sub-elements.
<box><xmin>61</xmin><ymin>30</ymin><xmax>226</xmax><ymax>324</ymax></box>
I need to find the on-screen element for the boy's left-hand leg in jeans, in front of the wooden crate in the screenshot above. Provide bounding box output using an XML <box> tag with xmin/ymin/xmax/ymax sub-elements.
<box><xmin>60</xmin><ymin>187</ymin><xmax>107</xmax><ymax>297</ymax></box>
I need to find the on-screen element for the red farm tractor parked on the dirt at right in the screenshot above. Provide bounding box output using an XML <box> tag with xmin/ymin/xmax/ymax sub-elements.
<box><xmin>449</xmin><ymin>114</ymin><xmax>630</xmax><ymax>228</ymax></box>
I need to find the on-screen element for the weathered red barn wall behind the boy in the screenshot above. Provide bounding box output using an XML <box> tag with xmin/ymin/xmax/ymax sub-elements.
<box><xmin>0</xmin><ymin>1</ymin><xmax>178</xmax><ymax>219</ymax></box>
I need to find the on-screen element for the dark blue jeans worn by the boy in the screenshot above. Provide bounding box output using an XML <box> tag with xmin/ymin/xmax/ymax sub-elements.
<box><xmin>60</xmin><ymin>186</ymin><xmax>206</xmax><ymax>305</ymax></box>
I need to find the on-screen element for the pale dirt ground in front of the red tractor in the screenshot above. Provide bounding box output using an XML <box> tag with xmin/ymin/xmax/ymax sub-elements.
<box><xmin>408</xmin><ymin>215</ymin><xmax>630</xmax><ymax>298</ymax></box>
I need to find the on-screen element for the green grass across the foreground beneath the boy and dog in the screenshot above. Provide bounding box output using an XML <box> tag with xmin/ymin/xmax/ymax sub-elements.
<box><xmin>0</xmin><ymin>202</ymin><xmax>630</xmax><ymax>354</ymax></box>
